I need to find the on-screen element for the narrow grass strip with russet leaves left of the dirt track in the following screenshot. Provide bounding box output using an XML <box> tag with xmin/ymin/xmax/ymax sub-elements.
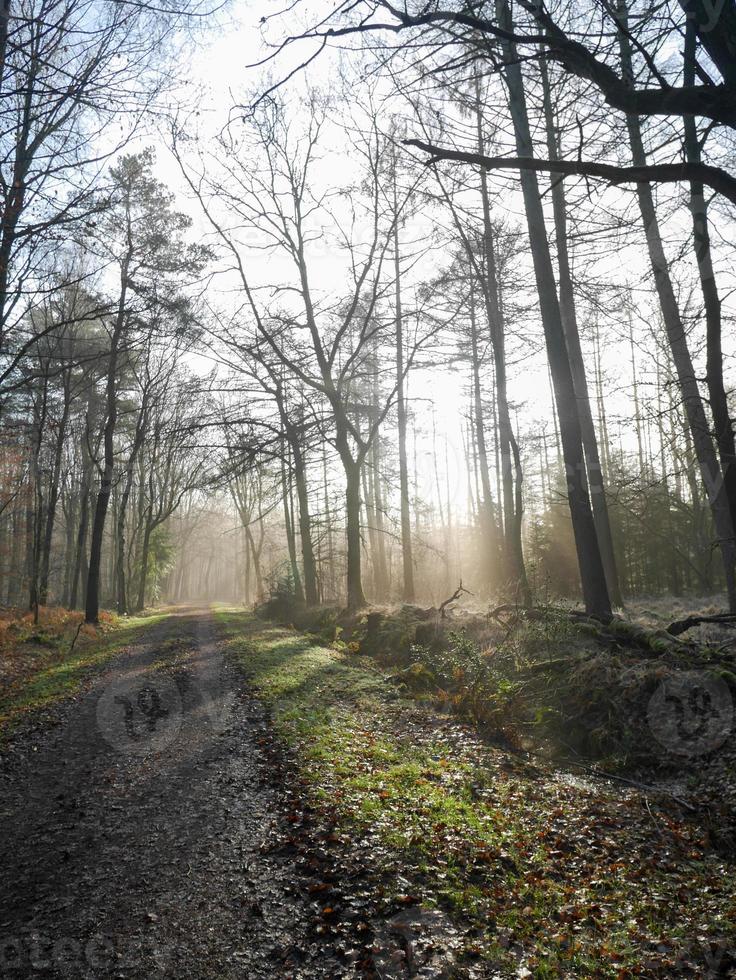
<box><xmin>0</xmin><ymin>613</ymin><xmax>166</xmax><ymax>747</ymax></box>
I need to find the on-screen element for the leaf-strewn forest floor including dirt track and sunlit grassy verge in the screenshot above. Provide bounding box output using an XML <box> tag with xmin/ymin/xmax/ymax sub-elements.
<box><xmin>0</xmin><ymin>609</ymin><xmax>736</xmax><ymax>980</ymax></box>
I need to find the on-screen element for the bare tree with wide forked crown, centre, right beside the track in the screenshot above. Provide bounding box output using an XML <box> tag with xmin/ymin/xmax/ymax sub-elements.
<box><xmin>175</xmin><ymin>98</ymin><xmax>436</xmax><ymax>608</ymax></box>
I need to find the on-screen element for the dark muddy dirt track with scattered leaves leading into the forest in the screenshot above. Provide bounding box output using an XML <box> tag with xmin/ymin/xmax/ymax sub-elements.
<box><xmin>0</xmin><ymin>609</ymin><xmax>334</xmax><ymax>980</ymax></box>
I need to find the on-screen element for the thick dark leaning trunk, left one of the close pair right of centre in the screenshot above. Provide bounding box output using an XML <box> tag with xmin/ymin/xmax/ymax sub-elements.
<box><xmin>497</xmin><ymin>0</ymin><xmax>611</xmax><ymax>618</ymax></box>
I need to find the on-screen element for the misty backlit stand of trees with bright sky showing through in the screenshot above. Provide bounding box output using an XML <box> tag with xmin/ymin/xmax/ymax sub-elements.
<box><xmin>0</xmin><ymin>0</ymin><xmax>736</xmax><ymax>622</ymax></box>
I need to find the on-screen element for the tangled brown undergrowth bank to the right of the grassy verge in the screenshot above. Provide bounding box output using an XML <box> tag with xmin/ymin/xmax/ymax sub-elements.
<box><xmin>265</xmin><ymin>597</ymin><xmax>736</xmax><ymax>772</ymax></box>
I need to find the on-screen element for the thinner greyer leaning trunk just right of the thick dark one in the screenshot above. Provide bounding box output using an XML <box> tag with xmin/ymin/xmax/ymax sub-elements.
<box><xmin>540</xmin><ymin>57</ymin><xmax>623</xmax><ymax>606</ymax></box>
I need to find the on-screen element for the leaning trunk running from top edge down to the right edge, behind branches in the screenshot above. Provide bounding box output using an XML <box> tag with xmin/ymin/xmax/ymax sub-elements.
<box><xmin>618</xmin><ymin>0</ymin><xmax>736</xmax><ymax>612</ymax></box>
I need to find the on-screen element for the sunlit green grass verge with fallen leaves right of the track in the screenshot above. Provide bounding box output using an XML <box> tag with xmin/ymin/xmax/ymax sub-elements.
<box><xmin>215</xmin><ymin>609</ymin><xmax>736</xmax><ymax>978</ymax></box>
